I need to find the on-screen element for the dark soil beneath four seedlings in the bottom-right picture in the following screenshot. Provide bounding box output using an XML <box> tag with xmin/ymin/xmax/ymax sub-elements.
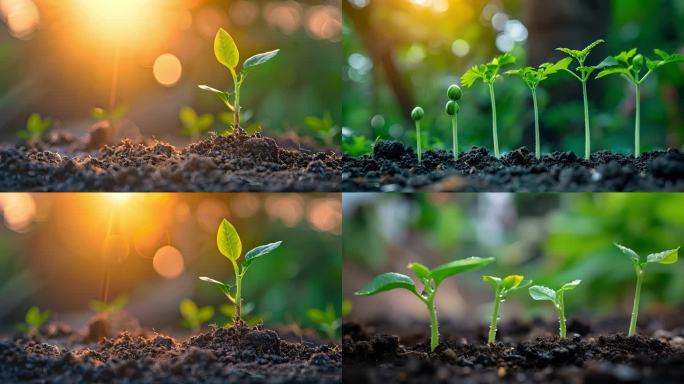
<box><xmin>343</xmin><ymin>320</ymin><xmax>684</xmax><ymax>384</ymax></box>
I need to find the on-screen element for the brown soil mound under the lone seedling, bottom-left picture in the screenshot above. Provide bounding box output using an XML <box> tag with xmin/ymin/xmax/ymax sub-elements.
<box><xmin>0</xmin><ymin>325</ymin><xmax>342</xmax><ymax>384</ymax></box>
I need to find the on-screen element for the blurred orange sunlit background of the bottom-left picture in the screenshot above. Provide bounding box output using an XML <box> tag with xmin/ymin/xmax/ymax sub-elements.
<box><xmin>0</xmin><ymin>193</ymin><xmax>342</xmax><ymax>338</ymax></box>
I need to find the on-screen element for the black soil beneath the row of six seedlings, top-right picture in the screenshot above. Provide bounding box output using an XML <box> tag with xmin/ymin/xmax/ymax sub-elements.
<box><xmin>342</xmin><ymin>141</ymin><xmax>684</xmax><ymax>192</ymax></box>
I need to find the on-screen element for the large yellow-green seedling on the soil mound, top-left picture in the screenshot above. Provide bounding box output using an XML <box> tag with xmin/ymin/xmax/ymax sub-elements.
<box><xmin>199</xmin><ymin>28</ymin><xmax>280</xmax><ymax>128</ymax></box>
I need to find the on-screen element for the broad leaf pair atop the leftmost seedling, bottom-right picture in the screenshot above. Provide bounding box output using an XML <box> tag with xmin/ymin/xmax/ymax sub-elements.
<box><xmin>354</xmin><ymin>257</ymin><xmax>494</xmax><ymax>296</ymax></box>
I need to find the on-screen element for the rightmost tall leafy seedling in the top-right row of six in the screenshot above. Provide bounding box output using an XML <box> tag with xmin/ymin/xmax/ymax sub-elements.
<box><xmin>596</xmin><ymin>48</ymin><xmax>684</xmax><ymax>157</ymax></box>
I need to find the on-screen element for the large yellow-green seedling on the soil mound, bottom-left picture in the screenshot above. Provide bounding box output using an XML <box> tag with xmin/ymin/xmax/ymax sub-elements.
<box><xmin>199</xmin><ymin>219</ymin><xmax>283</xmax><ymax>326</ymax></box>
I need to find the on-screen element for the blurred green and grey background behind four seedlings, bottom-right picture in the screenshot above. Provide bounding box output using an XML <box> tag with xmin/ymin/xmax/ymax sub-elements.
<box><xmin>343</xmin><ymin>193</ymin><xmax>684</xmax><ymax>327</ymax></box>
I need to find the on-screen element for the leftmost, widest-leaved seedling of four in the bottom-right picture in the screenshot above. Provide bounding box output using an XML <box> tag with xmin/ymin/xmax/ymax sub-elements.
<box><xmin>354</xmin><ymin>257</ymin><xmax>494</xmax><ymax>351</ymax></box>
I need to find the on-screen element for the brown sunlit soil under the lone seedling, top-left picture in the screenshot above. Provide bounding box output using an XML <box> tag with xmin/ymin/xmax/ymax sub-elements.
<box><xmin>0</xmin><ymin>132</ymin><xmax>341</xmax><ymax>192</ymax></box>
